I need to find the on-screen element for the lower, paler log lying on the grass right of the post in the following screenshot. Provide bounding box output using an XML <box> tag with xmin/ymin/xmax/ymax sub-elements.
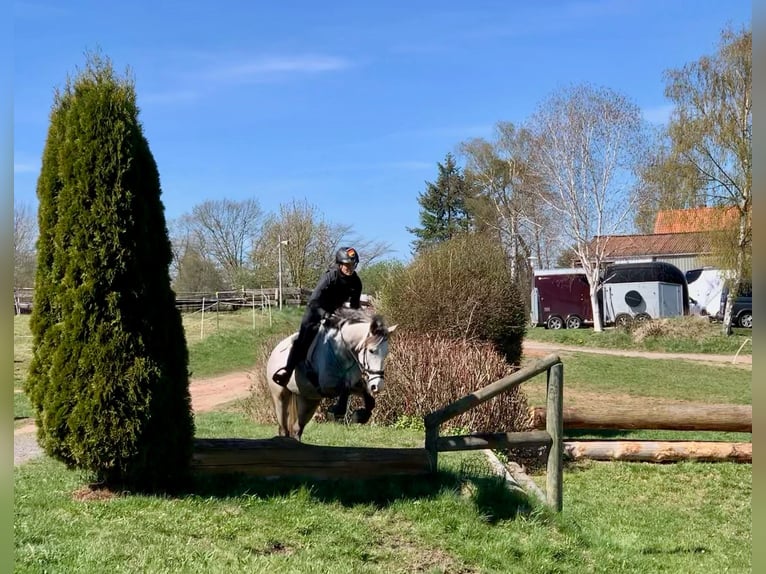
<box><xmin>564</xmin><ymin>440</ymin><xmax>753</xmax><ymax>463</ymax></box>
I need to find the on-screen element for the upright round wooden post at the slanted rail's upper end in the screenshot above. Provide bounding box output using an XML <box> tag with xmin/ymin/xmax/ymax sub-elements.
<box><xmin>545</xmin><ymin>363</ymin><xmax>564</xmax><ymax>512</ymax></box>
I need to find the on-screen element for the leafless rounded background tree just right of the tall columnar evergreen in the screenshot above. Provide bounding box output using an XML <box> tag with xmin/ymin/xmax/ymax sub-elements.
<box><xmin>178</xmin><ymin>199</ymin><xmax>263</xmax><ymax>288</ymax></box>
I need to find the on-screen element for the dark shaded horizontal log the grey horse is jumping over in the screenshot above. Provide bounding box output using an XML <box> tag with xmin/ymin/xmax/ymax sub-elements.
<box><xmin>191</xmin><ymin>437</ymin><xmax>432</xmax><ymax>479</ymax></box>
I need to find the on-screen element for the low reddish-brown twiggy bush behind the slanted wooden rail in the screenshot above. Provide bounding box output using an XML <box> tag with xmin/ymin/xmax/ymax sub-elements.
<box><xmin>372</xmin><ymin>333</ymin><xmax>531</xmax><ymax>432</ymax></box>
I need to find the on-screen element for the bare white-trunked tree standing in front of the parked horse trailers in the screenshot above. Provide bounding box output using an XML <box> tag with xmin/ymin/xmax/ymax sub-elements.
<box><xmin>530</xmin><ymin>85</ymin><xmax>647</xmax><ymax>331</ymax></box>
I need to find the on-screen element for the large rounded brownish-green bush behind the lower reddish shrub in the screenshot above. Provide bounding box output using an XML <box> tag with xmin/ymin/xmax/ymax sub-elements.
<box><xmin>380</xmin><ymin>234</ymin><xmax>527</xmax><ymax>364</ymax></box>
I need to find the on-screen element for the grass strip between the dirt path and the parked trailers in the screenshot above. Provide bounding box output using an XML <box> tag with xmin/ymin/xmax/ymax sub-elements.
<box><xmin>526</xmin><ymin>317</ymin><xmax>753</xmax><ymax>355</ymax></box>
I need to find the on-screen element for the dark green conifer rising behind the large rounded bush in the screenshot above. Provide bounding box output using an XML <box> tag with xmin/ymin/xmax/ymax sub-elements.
<box><xmin>407</xmin><ymin>153</ymin><xmax>473</xmax><ymax>252</ymax></box>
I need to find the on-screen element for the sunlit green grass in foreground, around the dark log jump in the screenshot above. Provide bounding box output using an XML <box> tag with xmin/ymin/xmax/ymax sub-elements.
<box><xmin>14</xmin><ymin>412</ymin><xmax>752</xmax><ymax>574</ymax></box>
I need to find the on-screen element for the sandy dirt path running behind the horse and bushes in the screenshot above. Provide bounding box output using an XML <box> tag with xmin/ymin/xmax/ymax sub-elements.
<box><xmin>13</xmin><ymin>341</ymin><xmax>753</xmax><ymax>465</ymax></box>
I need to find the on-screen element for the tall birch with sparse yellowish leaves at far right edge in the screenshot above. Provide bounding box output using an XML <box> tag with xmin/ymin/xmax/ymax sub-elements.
<box><xmin>658</xmin><ymin>29</ymin><xmax>753</xmax><ymax>333</ymax></box>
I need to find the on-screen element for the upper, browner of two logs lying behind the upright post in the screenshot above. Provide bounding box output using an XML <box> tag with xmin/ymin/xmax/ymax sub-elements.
<box><xmin>531</xmin><ymin>404</ymin><xmax>753</xmax><ymax>432</ymax></box>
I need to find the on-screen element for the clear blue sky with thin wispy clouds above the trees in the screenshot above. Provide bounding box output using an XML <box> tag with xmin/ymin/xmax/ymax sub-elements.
<box><xmin>13</xmin><ymin>0</ymin><xmax>752</xmax><ymax>259</ymax></box>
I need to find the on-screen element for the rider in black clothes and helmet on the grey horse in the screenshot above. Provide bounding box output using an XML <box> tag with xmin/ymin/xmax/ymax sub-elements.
<box><xmin>272</xmin><ymin>247</ymin><xmax>362</xmax><ymax>387</ymax></box>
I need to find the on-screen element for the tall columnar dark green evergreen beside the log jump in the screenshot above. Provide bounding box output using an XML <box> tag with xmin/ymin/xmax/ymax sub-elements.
<box><xmin>25</xmin><ymin>55</ymin><xmax>194</xmax><ymax>489</ymax></box>
